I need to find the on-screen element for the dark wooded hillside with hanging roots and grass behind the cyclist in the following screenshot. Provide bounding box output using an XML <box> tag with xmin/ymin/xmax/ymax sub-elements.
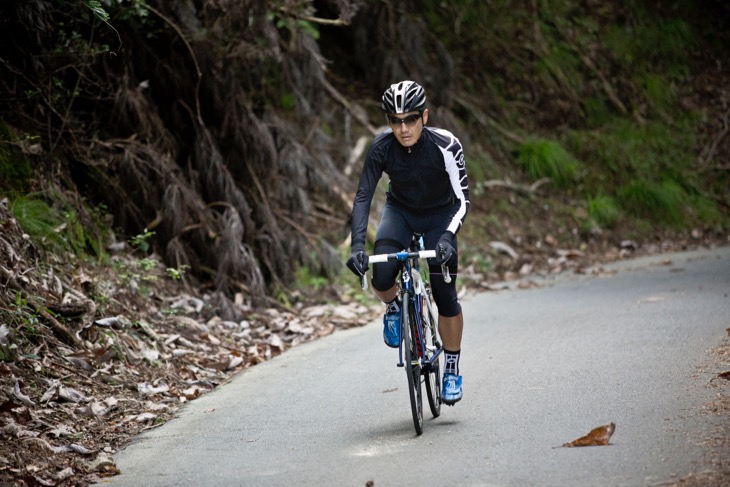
<box><xmin>0</xmin><ymin>0</ymin><xmax>730</xmax><ymax>313</ymax></box>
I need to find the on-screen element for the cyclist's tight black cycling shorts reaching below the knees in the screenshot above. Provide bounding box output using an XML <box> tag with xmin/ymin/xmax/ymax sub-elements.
<box><xmin>372</xmin><ymin>203</ymin><xmax>461</xmax><ymax>318</ymax></box>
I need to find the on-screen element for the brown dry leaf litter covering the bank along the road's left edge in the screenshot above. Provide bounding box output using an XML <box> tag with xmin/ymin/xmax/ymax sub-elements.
<box><xmin>0</xmin><ymin>202</ymin><xmax>380</xmax><ymax>486</ymax></box>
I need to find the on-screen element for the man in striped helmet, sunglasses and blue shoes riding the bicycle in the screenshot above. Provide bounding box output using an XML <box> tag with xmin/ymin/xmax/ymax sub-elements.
<box><xmin>347</xmin><ymin>81</ymin><xmax>469</xmax><ymax>405</ymax></box>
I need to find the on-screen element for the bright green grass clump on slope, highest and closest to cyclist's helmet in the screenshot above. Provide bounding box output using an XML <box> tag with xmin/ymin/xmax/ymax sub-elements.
<box><xmin>517</xmin><ymin>139</ymin><xmax>579</xmax><ymax>188</ymax></box>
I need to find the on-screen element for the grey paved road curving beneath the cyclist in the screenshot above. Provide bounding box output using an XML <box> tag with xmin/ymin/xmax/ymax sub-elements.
<box><xmin>105</xmin><ymin>247</ymin><xmax>730</xmax><ymax>487</ymax></box>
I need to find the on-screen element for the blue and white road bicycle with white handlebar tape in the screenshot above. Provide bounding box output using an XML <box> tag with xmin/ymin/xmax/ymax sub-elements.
<box><xmin>360</xmin><ymin>234</ymin><xmax>451</xmax><ymax>435</ymax></box>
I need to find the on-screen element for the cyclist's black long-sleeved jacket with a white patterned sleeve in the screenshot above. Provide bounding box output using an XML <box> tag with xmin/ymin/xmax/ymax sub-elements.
<box><xmin>352</xmin><ymin>127</ymin><xmax>469</xmax><ymax>251</ymax></box>
